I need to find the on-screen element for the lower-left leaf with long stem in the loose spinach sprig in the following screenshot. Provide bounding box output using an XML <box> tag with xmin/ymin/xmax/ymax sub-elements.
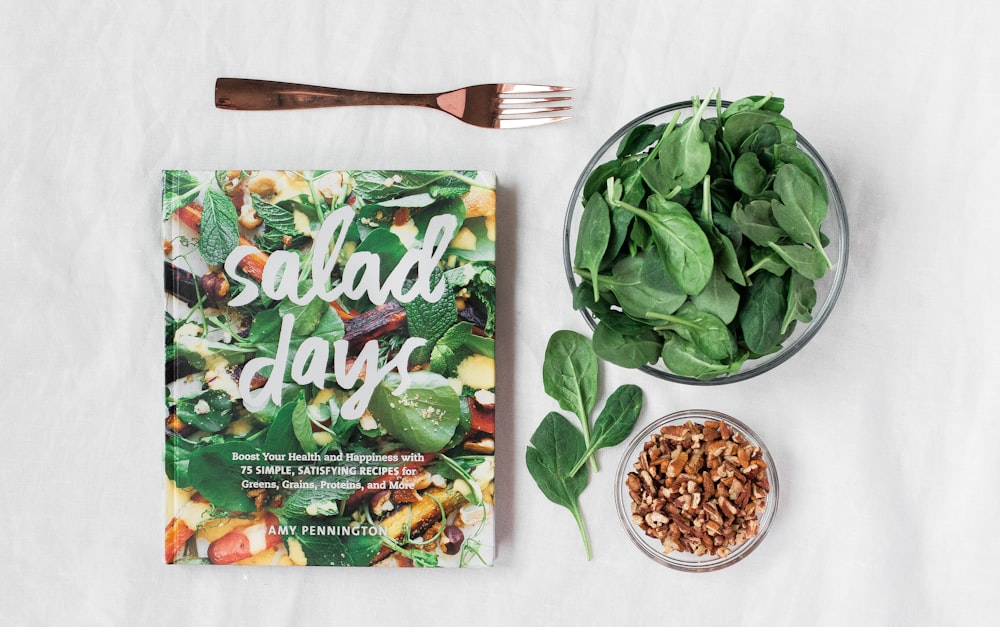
<box><xmin>525</xmin><ymin>412</ymin><xmax>591</xmax><ymax>560</ymax></box>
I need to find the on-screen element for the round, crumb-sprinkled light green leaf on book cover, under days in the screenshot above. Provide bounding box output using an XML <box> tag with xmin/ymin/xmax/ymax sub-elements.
<box><xmin>368</xmin><ymin>371</ymin><xmax>461</xmax><ymax>453</ymax></box>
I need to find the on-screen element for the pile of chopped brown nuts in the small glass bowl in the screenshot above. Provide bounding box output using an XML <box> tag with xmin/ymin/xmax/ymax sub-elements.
<box><xmin>625</xmin><ymin>420</ymin><xmax>771</xmax><ymax>557</ymax></box>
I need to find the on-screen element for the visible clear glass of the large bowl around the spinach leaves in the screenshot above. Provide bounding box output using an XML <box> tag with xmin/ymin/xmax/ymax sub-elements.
<box><xmin>563</xmin><ymin>100</ymin><xmax>849</xmax><ymax>385</ymax></box>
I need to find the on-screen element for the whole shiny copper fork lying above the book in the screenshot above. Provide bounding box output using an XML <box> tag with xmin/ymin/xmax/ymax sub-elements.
<box><xmin>215</xmin><ymin>78</ymin><xmax>573</xmax><ymax>128</ymax></box>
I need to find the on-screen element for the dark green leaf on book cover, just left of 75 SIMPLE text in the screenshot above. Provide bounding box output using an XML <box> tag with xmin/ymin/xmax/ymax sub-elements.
<box><xmin>188</xmin><ymin>440</ymin><xmax>260</xmax><ymax>512</ymax></box>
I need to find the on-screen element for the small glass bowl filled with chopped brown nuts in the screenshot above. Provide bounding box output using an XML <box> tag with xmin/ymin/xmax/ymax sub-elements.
<box><xmin>615</xmin><ymin>410</ymin><xmax>778</xmax><ymax>572</ymax></box>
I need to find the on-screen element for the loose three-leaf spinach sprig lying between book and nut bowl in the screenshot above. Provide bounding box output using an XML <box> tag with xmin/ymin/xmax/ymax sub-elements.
<box><xmin>525</xmin><ymin>331</ymin><xmax>642</xmax><ymax>560</ymax></box>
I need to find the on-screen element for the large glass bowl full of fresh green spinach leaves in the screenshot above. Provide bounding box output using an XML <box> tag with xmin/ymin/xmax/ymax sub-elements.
<box><xmin>563</xmin><ymin>96</ymin><xmax>848</xmax><ymax>385</ymax></box>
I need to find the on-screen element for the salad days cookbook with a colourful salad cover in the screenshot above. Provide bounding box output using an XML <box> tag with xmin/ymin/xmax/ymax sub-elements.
<box><xmin>163</xmin><ymin>170</ymin><xmax>496</xmax><ymax>567</ymax></box>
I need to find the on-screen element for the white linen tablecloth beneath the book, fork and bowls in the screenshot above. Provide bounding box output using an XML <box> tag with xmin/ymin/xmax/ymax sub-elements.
<box><xmin>0</xmin><ymin>0</ymin><xmax>1000</xmax><ymax>625</ymax></box>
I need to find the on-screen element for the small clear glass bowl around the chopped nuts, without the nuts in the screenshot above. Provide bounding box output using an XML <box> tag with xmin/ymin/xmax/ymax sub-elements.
<box><xmin>615</xmin><ymin>409</ymin><xmax>778</xmax><ymax>572</ymax></box>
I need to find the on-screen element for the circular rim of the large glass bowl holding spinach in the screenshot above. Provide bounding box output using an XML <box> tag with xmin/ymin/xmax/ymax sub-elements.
<box><xmin>563</xmin><ymin>99</ymin><xmax>850</xmax><ymax>386</ymax></box>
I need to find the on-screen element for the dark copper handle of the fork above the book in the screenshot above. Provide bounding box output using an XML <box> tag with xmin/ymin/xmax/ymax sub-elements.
<box><xmin>215</xmin><ymin>78</ymin><xmax>436</xmax><ymax>111</ymax></box>
